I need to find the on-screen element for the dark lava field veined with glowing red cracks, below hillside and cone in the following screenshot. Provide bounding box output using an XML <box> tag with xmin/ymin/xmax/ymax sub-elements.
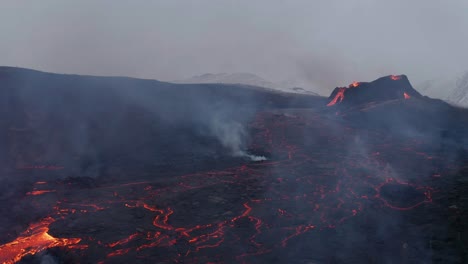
<box><xmin>0</xmin><ymin>110</ymin><xmax>450</xmax><ymax>263</ymax></box>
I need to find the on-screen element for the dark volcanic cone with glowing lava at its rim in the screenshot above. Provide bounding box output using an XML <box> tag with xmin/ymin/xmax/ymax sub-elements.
<box><xmin>327</xmin><ymin>75</ymin><xmax>421</xmax><ymax>106</ymax></box>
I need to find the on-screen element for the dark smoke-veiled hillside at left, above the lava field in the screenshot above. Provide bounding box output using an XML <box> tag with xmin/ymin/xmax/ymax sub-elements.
<box><xmin>0</xmin><ymin>67</ymin><xmax>324</xmax><ymax>179</ymax></box>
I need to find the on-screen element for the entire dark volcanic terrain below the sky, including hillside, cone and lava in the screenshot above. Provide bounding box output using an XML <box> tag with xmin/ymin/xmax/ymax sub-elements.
<box><xmin>0</xmin><ymin>67</ymin><xmax>468</xmax><ymax>263</ymax></box>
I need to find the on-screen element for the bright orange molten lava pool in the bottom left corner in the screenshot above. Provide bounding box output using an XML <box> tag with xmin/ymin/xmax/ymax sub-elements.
<box><xmin>0</xmin><ymin>217</ymin><xmax>81</xmax><ymax>264</ymax></box>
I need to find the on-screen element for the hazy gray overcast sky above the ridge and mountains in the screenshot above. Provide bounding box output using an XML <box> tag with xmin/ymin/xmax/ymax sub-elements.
<box><xmin>0</xmin><ymin>0</ymin><xmax>468</xmax><ymax>91</ymax></box>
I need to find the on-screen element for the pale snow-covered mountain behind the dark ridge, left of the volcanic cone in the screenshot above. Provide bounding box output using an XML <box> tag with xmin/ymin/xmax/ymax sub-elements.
<box><xmin>173</xmin><ymin>72</ymin><xmax>318</xmax><ymax>95</ymax></box>
